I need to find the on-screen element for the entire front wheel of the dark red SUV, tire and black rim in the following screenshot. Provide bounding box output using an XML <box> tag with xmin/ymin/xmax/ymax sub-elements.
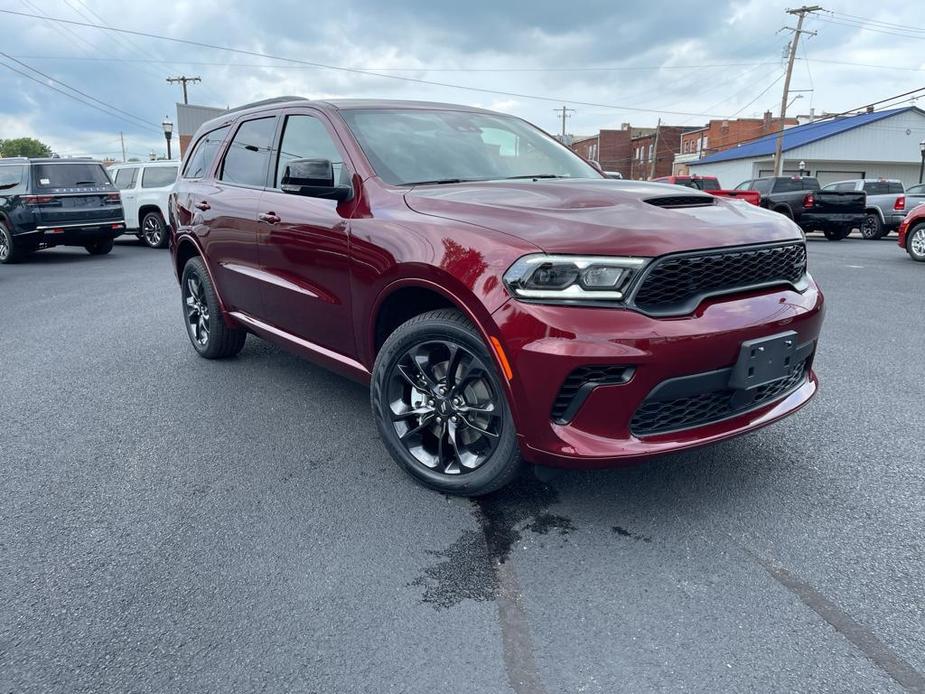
<box><xmin>370</xmin><ymin>309</ymin><xmax>522</xmax><ymax>496</ymax></box>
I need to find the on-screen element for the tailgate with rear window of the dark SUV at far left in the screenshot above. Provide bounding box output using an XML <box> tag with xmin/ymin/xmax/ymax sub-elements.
<box><xmin>26</xmin><ymin>161</ymin><xmax>123</xmax><ymax>229</ymax></box>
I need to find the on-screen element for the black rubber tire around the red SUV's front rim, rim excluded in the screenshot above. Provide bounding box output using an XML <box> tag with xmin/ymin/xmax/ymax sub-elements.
<box><xmin>370</xmin><ymin>312</ymin><xmax>519</xmax><ymax>495</ymax></box>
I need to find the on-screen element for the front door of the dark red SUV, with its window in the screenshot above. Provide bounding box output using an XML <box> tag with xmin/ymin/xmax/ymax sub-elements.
<box><xmin>258</xmin><ymin>110</ymin><xmax>356</xmax><ymax>356</ymax></box>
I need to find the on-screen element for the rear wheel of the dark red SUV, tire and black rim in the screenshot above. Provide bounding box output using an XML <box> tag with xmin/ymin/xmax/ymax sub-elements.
<box><xmin>180</xmin><ymin>258</ymin><xmax>247</xmax><ymax>359</ymax></box>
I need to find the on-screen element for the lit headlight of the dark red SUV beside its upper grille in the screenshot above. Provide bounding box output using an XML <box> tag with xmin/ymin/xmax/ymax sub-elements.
<box><xmin>504</xmin><ymin>253</ymin><xmax>648</xmax><ymax>301</ymax></box>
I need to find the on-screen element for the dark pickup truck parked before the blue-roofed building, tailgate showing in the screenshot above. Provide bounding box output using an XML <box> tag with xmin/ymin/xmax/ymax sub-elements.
<box><xmin>736</xmin><ymin>176</ymin><xmax>867</xmax><ymax>241</ymax></box>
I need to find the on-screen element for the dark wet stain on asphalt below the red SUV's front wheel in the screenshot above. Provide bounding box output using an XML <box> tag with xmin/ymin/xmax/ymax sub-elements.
<box><xmin>409</xmin><ymin>473</ymin><xmax>575</xmax><ymax>609</ymax></box>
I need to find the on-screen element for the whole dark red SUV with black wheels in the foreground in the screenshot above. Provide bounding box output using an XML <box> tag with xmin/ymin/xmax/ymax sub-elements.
<box><xmin>171</xmin><ymin>98</ymin><xmax>823</xmax><ymax>495</ymax></box>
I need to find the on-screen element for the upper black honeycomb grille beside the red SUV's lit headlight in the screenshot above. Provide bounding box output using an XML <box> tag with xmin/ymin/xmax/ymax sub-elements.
<box><xmin>633</xmin><ymin>243</ymin><xmax>806</xmax><ymax>314</ymax></box>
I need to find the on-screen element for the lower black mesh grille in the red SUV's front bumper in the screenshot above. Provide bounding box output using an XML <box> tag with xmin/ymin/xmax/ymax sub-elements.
<box><xmin>630</xmin><ymin>361</ymin><xmax>807</xmax><ymax>436</ymax></box>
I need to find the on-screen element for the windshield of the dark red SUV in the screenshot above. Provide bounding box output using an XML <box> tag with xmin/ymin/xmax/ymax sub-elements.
<box><xmin>342</xmin><ymin>109</ymin><xmax>602</xmax><ymax>185</ymax></box>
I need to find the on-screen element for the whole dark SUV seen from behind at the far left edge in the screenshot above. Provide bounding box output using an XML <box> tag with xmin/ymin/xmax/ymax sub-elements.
<box><xmin>0</xmin><ymin>157</ymin><xmax>125</xmax><ymax>263</ymax></box>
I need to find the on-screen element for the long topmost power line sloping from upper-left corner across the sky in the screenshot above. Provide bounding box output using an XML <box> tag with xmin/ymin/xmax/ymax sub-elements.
<box><xmin>0</xmin><ymin>10</ymin><xmax>756</xmax><ymax>117</ymax></box>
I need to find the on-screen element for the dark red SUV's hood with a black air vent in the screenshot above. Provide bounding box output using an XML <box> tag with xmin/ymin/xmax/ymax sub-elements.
<box><xmin>405</xmin><ymin>179</ymin><xmax>801</xmax><ymax>256</ymax></box>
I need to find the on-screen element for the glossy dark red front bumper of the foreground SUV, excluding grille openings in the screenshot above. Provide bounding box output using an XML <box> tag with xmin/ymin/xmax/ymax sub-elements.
<box><xmin>494</xmin><ymin>279</ymin><xmax>824</xmax><ymax>468</ymax></box>
